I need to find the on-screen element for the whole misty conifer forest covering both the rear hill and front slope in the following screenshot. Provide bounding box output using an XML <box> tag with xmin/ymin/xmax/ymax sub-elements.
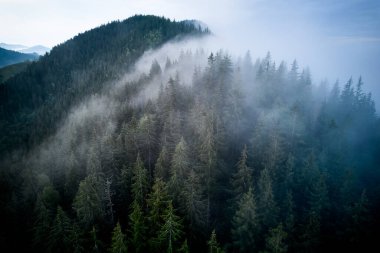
<box><xmin>0</xmin><ymin>16</ymin><xmax>380</xmax><ymax>253</ymax></box>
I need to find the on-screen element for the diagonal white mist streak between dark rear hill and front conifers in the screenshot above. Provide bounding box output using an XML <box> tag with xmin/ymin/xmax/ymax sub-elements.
<box><xmin>27</xmin><ymin>38</ymin><xmax>211</xmax><ymax>174</ymax></box>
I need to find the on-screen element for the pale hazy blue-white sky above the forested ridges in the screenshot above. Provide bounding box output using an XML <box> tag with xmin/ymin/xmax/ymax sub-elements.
<box><xmin>0</xmin><ymin>0</ymin><xmax>380</xmax><ymax>105</ymax></box>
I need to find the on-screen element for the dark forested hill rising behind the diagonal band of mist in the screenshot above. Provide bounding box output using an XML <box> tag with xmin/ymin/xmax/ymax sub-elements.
<box><xmin>0</xmin><ymin>15</ymin><xmax>207</xmax><ymax>155</ymax></box>
